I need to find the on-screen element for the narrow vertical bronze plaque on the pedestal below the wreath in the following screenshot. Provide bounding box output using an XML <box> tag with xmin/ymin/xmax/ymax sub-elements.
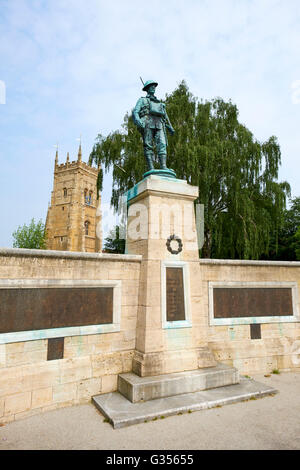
<box><xmin>166</xmin><ymin>268</ymin><xmax>185</xmax><ymax>321</ymax></box>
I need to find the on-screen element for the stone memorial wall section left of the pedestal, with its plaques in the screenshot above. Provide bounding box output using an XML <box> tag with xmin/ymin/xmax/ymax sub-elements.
<box><xmin>0</xmin><ymin>249</ymin><xmax>141</xmax><ymax>423</ymax></box>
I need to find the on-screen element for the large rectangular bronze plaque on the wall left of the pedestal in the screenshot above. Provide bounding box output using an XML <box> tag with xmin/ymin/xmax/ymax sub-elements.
<box><xmin>0</xmin><ymin>287</ymin><xmax>113</xmax><ymax>333</ymax></box>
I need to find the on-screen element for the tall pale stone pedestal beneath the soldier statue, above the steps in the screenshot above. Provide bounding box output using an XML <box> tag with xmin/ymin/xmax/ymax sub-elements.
<box><xmin>127</xmin><ymin>175</ymin><xmax>216</xmax><ymax>377</ymax></box>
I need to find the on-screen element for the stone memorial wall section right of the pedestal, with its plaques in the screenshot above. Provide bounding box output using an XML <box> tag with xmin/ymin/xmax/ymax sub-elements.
<box><xmin>204</xmin><ymin>260</ymin><xmax>300</xmax><ymax>375</ymax></box>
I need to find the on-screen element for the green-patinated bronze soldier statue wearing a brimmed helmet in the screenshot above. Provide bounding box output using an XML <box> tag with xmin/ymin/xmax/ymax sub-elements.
<box><xmin>132</xmin><ymin>80</ymin><xmax>175</xmax><ymax>171</ymax></box>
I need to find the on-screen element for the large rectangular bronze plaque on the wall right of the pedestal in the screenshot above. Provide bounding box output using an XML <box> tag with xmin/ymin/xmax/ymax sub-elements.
<box><xmin>213</xmin><ymin>287</ymin><xmax>293</xmax><ymax>318</ymax></box>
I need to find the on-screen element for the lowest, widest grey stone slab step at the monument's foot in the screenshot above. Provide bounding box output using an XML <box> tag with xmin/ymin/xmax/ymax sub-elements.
<box><xmin>92</xmin><ymin>378</ymin><xmax>278</xmax><ymax>428</ymax></box>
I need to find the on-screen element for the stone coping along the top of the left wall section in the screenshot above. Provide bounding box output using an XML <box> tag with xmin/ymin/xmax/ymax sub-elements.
<box><xmin>0</xmin><ymin>248</ymin><xmax>143</xmax><ymax>262</ymax></box>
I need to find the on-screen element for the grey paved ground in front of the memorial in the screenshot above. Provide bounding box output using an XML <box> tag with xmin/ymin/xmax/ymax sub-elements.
<box><xmin>0</xmin><ymin>372</ymin><xmax>300</xmax><ymax>450</ymax></box>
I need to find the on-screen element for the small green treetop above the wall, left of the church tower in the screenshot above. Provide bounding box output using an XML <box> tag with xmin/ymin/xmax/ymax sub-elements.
<box><xmin>12</xmin><ymin>219</ymin><xmax>46</xmax><ymax>249</ymax></box>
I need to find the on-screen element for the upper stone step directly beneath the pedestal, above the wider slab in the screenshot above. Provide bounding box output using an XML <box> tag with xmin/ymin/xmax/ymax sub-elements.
<box><xmin>118</xmin><ymin>364</ymin><xmax>239</xmax><ymax>403</ymax></box>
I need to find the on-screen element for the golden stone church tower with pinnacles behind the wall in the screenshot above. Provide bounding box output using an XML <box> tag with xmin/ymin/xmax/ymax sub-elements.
<box><xmin>46</xmin><ymin>143</ymin><xmax>102</xmax><ymax>253</ymax></box>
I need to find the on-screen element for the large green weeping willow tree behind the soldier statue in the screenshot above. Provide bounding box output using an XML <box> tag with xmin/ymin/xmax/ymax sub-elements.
<box><xmin>90</xmin><ymin>81</ymin><xmax>290</xmax><ymax>259</ymax></box>
